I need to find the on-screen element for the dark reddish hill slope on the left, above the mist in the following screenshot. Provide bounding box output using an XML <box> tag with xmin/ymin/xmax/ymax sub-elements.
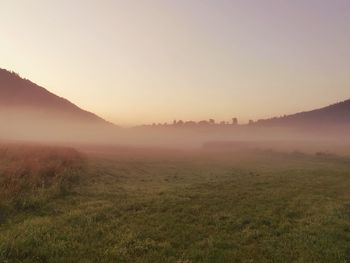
<box><xmin>0</xmin><ymin>68</ymin><xmax>109</xmax><ymax>124</ymax></box>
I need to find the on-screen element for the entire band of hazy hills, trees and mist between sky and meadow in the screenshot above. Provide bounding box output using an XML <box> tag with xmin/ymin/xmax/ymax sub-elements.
<box><xmin>0</xmin><ymin>69</ymin><xmax>350</xmax><ymax>145</ymax></box>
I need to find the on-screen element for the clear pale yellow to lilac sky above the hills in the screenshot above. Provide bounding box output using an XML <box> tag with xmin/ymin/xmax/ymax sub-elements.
<box><xmin>0</xmin><ymin>0</ymin><xmax>350</xmax><ymax>125</ymax></box>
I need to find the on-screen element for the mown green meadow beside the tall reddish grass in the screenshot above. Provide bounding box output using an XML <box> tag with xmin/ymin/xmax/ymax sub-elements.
<box><xmin>0</xmin><ymin>145</ymin><xmax>350</xmax><ymax>263</ymax></box>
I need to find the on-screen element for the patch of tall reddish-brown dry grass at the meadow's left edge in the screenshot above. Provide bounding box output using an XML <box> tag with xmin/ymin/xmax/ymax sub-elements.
<box><xmin>0</xmin><ymin>145</ymin><xmax>84</xmax><ymax>207</ymax></box>
